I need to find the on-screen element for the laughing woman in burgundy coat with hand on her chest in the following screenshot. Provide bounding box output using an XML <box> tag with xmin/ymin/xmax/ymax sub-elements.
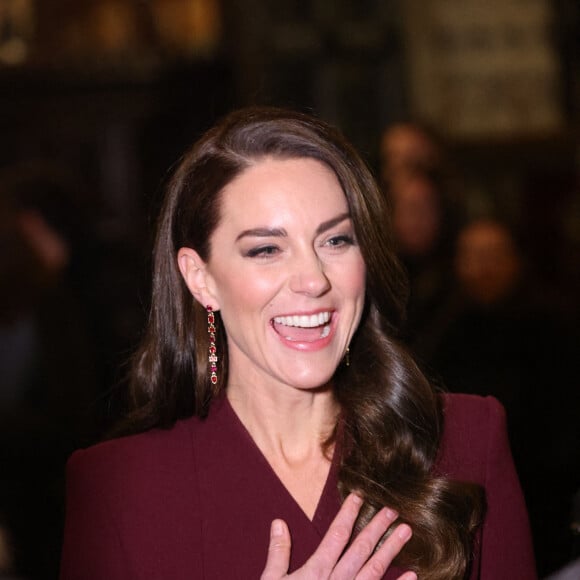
<box><xmin>61</xmin><ymin>109</ymin><xmax>534</xmax><ymax>580</ymax></box>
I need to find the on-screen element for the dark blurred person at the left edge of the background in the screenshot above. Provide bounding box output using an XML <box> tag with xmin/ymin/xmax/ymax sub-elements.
<box><xmin>0</xmin><ymin>163</ymin><xmax>96</xmax><ymax>579</ymax></box>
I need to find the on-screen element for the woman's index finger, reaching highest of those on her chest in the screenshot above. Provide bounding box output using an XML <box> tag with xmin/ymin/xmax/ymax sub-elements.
<box><xmin>304</xmin><ymin>493</ymin><xmax>362</xmax><ymax>578</ymax></box>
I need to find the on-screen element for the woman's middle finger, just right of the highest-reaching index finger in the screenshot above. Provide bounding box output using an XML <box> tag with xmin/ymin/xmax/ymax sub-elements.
<box><xmin>332</xmin><ymin>508</ymin><xmax>398</xmax><ymax>580</ymax></box>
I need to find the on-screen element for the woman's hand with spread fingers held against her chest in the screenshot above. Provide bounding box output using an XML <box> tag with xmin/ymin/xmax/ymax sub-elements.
<box><xmin>261</xmin><ymin>493</ymin><xmax>417</xmax><ymax>580</ymax></box>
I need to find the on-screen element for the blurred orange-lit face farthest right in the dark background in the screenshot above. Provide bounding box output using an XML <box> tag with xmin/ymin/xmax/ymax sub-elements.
<box><xmin>455</xmin><ymin>220</ymin><xmax>522</xmax><ymax>305</ymax></box>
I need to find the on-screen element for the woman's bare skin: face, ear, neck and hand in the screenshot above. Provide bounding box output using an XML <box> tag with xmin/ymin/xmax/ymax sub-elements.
<box><xmin>178</xmin><ymin>158</ymin><xmax>410</xmax><ymax>580</ymax></box>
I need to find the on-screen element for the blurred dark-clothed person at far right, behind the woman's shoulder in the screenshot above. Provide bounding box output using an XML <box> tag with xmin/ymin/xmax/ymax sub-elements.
<box><xmin>424</xmin><ymin>217</ymin><xmax>580</xmax><ymax>572</ymax></box>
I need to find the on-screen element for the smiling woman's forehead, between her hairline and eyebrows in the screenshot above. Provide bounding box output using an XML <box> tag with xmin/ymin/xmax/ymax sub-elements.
<box><xmin>221</xmin><ymin>157</ymin><xmax>348</xmax><ymax>221</ymax></box>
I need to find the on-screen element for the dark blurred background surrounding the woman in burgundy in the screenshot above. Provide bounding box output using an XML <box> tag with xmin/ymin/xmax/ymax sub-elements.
<box><xmin>0</xmin><ymin>0</ymin><xmax>580</xmax><ymax>580</ymax></box>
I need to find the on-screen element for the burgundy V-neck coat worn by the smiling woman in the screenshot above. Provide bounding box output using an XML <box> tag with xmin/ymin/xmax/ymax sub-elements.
<box><xmin>61</xmin><ymin>395</ymin><xmax>536</xmax><ymax>580</ymax></box>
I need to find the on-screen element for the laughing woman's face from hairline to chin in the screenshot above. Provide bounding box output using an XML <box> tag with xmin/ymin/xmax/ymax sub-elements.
<box><xmin>188</xmin><ymin>158</ymin><xmax>365</xmax><ymax>389</ymax></box>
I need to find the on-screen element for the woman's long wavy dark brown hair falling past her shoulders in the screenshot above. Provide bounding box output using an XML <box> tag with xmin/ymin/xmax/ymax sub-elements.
<box><xmin>123</xmin><ymin>108</ymin><xmax>482</xmax><ymax>580</ymax></box>
